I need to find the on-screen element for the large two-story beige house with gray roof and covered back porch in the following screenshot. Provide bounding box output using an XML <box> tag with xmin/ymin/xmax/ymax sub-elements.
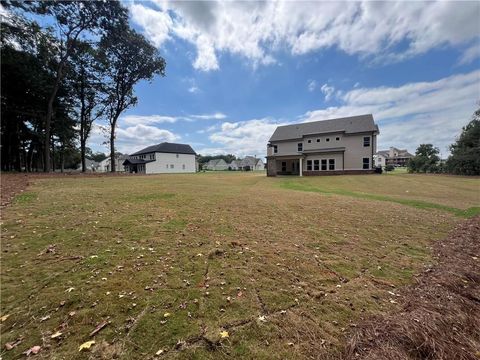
<box><xmin>267</xmin><ymin>114</ymin><xmax>379</xmax><ymax>176</ymax></box>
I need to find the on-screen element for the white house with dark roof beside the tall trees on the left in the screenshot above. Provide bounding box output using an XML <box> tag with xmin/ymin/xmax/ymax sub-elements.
<box><xmin>123</xmin><ymin>142</ymin><xmax>197</xmax><ymax>174</ymax></box>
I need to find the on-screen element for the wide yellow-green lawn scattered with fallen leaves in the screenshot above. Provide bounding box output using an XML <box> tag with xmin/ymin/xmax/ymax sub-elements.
<box><xmin>1</xmin><ymin>172</ymin><xmax>480</xmax><ymax>359</ymax></box>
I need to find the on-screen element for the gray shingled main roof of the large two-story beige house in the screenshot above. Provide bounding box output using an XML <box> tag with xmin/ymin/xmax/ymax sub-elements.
<box><xmin>270</xmin><ymin>114</ymin><xmax>378</xmax><ymax>141</ymax></box>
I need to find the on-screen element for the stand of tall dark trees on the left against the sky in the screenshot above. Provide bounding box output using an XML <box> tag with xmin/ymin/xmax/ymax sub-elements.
<box><xmin>0</xmin><ymin>0</ymin><xmax>166</xmax><ymax>172</ymax></box>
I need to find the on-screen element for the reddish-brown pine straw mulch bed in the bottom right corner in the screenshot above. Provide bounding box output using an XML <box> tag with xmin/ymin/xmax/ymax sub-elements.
<box><xmin>342</xmin><ymin>217</ymin><xmax>480</xmax><ymax>360</ymax></box>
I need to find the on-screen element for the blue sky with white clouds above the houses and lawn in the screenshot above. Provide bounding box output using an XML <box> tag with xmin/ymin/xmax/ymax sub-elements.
<box><xmin>90</xmin><ymin>0</ymin><xmax>480</xmax><ymax>157</ymax></box>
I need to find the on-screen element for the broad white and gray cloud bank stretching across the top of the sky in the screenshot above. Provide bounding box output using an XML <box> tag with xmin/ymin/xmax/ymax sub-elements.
<box><xmin>130</xmin><ymin>0</ymin><xmax>480</xmax><ymax>71</ymax></box>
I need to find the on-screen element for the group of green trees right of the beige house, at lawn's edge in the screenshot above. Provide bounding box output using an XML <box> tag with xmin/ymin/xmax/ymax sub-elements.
<box><xmin>407</xmin><ymin>109</ymin><xmax>480</xmax><ymax>175</ymax></box>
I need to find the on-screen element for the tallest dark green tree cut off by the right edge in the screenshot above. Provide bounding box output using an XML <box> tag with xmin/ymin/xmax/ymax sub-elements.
<box><xmin>446</xmin><ymin>108</ymin><xmax>480</xmax><ymax>175</ymax></box>
